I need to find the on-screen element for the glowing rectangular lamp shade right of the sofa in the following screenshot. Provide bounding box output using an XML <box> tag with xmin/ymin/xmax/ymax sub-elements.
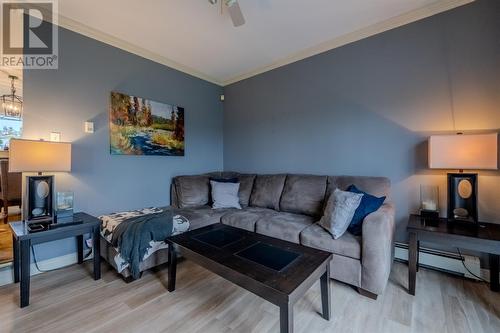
<box><xmin>429</xmin><ymin>133</ymin><xmax>498</xmax><ymax>170</ymax></box>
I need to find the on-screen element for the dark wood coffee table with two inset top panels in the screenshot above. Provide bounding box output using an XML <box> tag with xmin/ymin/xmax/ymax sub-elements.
<box><xmin>167</xmin><ymin>224</ymin><xmax>332</xmax><ymax>333</ymax></box>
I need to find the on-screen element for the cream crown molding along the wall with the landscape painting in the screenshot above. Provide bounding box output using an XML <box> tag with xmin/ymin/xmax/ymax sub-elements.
<box><xmin>57</xmin><ymin>14</ymin><xmax>222</xmax><ymax>86</ymax></box>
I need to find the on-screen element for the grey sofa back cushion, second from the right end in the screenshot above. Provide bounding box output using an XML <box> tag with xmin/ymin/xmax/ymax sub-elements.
<box><xmin>280</xmin><ymin>175</ymin><xmax>327</xmax><ymax>216</ymax></box>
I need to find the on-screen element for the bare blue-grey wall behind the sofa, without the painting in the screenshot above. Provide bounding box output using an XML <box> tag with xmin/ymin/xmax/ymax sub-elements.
<box><xmin>224</xmin><ymin>0</ymin><xmax>500</xmax><ymax>240</ymax></box>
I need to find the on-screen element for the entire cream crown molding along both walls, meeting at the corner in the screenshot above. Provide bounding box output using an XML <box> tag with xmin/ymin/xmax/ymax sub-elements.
<box><xmin>47</xmin><ymin>0</ymin><xmax>476</xmax><ymax>86</ymax></box>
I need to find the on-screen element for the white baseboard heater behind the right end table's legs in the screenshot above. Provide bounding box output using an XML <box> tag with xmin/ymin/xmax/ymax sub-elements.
<box><xmin>395</xmin><ymin>243</ymin><xmax>484</xmax><ymax>280</ymax></box>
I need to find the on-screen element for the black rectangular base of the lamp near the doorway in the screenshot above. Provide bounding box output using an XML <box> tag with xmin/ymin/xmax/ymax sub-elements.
<box><xmin>26</xmin><ymin>176</ymin><xmax>54</xmax><ymax>222</ymax></box>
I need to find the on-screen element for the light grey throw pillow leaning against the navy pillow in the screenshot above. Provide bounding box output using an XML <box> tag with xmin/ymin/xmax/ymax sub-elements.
<box><xmin>319</xmin><ymin>189</ymin><xmax>363</xmax><ymax>239</ymax></box>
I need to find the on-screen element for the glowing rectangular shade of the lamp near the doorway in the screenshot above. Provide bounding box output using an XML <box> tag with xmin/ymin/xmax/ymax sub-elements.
<box><xmin>9</xmin><ymin>139</ymin><xmax>71</xmax><ymax>172</ymax></box>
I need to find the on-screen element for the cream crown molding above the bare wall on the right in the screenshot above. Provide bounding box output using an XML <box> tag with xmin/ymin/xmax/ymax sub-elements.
<box><xmin>222</xmin><ymin>0</ymin><xmax>476</xmax><ymax>86</ymax></box>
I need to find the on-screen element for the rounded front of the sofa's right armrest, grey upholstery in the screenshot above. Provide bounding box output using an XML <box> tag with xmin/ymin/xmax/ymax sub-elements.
<box><xmin>361</xmin><ymin>203</ymin><xmax>395</xmax><ymax>295</ymax></box>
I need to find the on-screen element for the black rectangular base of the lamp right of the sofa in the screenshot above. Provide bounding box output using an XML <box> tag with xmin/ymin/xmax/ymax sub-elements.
<box><xmin>448</xmin><ymin>173</ymin><xmax>478</xmax><ymax>223</ymax></box>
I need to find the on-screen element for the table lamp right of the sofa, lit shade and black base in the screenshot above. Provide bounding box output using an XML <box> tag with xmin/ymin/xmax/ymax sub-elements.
<box><xmin>429</xmin><ymin>133</ymin><xmax>498</xmax><ymax>223</ymax></box>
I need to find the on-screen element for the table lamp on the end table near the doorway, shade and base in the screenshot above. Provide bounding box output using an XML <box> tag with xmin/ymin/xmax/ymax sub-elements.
<box><xmin>9</xmin><ymin>139</ymin><xmax>71</xmax><ymax>223</ymax></box>
